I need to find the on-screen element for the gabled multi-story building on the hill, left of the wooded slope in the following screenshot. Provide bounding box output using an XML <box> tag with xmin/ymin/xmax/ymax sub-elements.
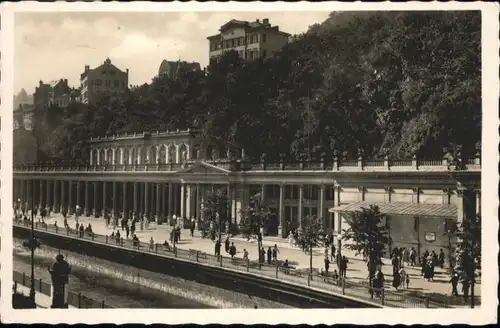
<box><xmin>80</xmin><ymin>58</ymin><xmax>128</xmax><ymax>104</ymax></box>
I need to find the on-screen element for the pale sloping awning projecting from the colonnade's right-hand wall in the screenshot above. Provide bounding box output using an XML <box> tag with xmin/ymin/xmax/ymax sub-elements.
<box><xmin>328</xmin><ymin>202</ymin><xmax>457</xmax><ymax>218</ymax></box>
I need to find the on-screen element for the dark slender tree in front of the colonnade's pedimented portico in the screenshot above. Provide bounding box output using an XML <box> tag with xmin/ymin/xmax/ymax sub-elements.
<box><xmin>203</xmin><ymin>189</ymin><xmax>229</xmax><ymax>241</ymax></box>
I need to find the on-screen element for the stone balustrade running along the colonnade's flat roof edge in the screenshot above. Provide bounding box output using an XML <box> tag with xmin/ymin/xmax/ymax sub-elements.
<box><xmin>14</xmin><ymin>156</ymin><xmax>481</xmax><ymax>172</ymax></box>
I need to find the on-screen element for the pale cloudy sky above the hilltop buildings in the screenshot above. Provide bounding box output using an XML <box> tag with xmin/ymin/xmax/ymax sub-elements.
<box><xmin>14</xmin><ymin>11</ymin><xmax>329</xmax><ymax>94</ymax></box>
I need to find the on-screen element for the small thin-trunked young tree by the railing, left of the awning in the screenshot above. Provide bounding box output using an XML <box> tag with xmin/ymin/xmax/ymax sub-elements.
<box><xmin>298</xmin><ymin>215</ymin><xmax>326</xmax><ymax>277</ymax></box>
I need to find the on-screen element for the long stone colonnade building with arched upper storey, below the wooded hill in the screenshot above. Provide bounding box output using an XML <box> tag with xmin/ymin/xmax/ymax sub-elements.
<box><xmin>14</xmin><ymin>130</ymin><xmax>481</xmax><ymax>256</ymax></box>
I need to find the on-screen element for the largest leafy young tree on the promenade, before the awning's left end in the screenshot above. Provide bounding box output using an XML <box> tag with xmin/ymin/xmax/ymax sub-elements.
<box><xmin>342</xmin><ymin>205</ymin><xmax>391</xmax><ymax>293</ymax></box>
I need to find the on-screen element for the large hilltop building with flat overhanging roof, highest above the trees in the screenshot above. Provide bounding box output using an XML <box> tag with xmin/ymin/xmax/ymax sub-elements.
<box><xmin>207</xmin><ymin>18</ymin><xmax>290</xmax><ymax>60</ymax></box>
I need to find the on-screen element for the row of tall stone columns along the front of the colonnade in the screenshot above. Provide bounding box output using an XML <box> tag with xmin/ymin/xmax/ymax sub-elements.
<box><xmin>14</xmin><ymin>180</ymin><xmax>332</xmax><ymax>235</ymax></box>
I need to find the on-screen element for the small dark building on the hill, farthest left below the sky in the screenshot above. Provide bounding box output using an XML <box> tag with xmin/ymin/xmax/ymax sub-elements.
<box><xmin>33</xmin><ymin>79</ymin><xmax>71</xmax><ymax>108</ymax></box>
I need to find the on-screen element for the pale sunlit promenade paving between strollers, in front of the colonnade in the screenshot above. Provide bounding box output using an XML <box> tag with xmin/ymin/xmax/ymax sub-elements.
<box><xmin>39</xmin><ymin>214</ymin><xmax>481</xmax><ymax>304</ymax></box>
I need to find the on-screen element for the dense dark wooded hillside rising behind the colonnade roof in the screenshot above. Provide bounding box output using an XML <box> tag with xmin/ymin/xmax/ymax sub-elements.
<box><xmin>16</xmin><ymin>11</ymin><xmax>481</xmax><ymax>164</ymax></box>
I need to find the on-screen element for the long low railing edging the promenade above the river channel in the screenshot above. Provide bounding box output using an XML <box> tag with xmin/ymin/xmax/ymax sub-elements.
<box><xmin>14</xmin><ymin>220</ymin><xmax>450</xmax><ymax>308</ymax></box>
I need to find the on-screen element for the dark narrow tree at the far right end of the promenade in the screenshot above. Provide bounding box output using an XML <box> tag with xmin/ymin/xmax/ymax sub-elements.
<box><xmin>456</xmin><ymin>214</ymin><xmax>481</xmax><ymax>307</ymax></box>
